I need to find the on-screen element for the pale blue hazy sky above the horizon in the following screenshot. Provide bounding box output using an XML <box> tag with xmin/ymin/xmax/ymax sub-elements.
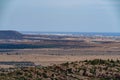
<box><xmin>0</xmin><ymin>0</ymin><xmax>120</xmax><ymax>32</ymax></box>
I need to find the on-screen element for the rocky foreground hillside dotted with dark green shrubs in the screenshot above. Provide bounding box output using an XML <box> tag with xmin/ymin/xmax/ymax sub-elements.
<box><xmin>0</xmin><ymin>59</ymin><xmax>120</xmax><ymax>80</ymax></box>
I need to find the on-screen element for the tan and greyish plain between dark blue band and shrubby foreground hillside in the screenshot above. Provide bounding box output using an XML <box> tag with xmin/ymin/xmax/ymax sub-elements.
<box><xmin>0</xmin><ymin>43</ymin><xmax>120</xmax><ymax>66</ymax></box>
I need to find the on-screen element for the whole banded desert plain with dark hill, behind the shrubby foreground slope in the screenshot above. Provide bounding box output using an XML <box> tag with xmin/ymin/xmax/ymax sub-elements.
<box><xmin>0</xmin><ymin>31</ymin><xmax>120</xmax><ymax>67</ymax></box>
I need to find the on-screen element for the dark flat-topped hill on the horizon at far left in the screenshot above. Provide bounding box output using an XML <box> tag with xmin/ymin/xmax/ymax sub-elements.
<box><xmin>0</xmin><ymin>30</ymin><xmax>23</xmax><ymax>39</ymax></box>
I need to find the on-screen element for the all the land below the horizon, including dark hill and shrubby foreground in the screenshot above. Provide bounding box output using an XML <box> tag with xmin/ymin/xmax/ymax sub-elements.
<box><xmin>0</xmin><ymin>31</ymin><xmax>120</xmax><ymax>80</ymax></box>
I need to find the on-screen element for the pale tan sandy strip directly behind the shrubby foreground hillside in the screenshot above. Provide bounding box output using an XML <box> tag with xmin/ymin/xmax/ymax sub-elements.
<box><xmin>0</xmin><ymin>54</ymin><xmax>120</xmax><ymax>66</ymax></box>
